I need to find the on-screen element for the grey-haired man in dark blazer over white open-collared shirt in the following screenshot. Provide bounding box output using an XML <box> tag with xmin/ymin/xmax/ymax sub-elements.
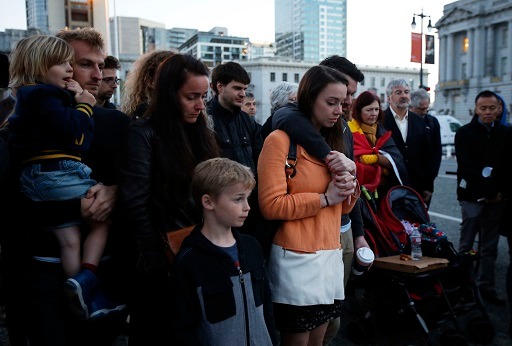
<box><xmin>383</xmin><ymin>79</ymin><xmax>435</xmax><ymax>202</ymax></box>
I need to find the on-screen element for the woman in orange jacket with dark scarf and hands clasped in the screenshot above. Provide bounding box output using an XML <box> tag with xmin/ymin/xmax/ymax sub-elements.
<box><xmin>258</xmin><ymin>66</ymin><xmax>360</xmax><ymax>346</ymax></box>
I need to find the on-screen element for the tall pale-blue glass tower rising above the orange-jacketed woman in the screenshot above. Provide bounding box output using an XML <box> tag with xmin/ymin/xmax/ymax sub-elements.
<box><xmin>275</xmin><ymin>0</ymin><xmax>347</xmax><ymax>63</ymax></box>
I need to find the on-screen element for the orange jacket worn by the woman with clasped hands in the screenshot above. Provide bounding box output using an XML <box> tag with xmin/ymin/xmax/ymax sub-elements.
<box><xmin>258</xmin><ymin>130</ymin><xmax>360</xmax><ymax>252</ymax></box>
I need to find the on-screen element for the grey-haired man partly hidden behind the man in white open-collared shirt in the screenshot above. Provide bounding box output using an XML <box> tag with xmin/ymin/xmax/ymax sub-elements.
<box><xmin>409</xmin><ymin>89</ymin><xmax>443</xmax><ymax>206</ymax></box>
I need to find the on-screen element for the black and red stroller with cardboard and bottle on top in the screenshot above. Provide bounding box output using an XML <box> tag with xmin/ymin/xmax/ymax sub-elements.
<box><xmin>345</xmin><ymin>186</ymin><xmax>495</xmax><ymax>345</ymax></box>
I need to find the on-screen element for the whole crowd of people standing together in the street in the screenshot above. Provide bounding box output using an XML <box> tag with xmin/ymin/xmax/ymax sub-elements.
<box><xmin>0</xmin><ymin>28</ymin><xmax>512</xmax><ymax>346</ymax></box>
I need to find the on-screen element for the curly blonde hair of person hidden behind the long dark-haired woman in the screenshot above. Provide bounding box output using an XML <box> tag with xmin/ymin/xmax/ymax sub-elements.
<box><xmin>121</xmin><ymin>50</ymin><xmax>176</xmax><ymax>116</ymax></box>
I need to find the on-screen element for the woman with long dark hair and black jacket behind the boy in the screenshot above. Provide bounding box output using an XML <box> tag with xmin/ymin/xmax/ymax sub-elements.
<box><xmin>120</xmin><ymin>54</ymin><xmax>219</xmax><ymax>345</ymax></box>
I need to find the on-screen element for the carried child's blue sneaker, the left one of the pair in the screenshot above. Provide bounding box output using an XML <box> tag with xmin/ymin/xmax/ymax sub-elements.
<box><xmin>64</xmin><ymin>269</ymin><xmax>98</xmax><ymax>320</ymax></box>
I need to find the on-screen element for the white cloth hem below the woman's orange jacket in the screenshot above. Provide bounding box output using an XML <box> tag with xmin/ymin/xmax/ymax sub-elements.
<box><xmin>267</xmin><ymin>244</ymin><xmax>345</xmax><ymax>306</ymax></box>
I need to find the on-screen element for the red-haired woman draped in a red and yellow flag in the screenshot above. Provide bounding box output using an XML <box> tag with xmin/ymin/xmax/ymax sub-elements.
<box><xmin>348</xmin><ymin>91</ymin><xmax>409</xmax><ymax>198</ymax></box>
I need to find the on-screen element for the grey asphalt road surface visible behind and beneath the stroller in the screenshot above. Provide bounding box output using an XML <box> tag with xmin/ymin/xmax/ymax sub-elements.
<box><xmin>0</xmin><ymin>158</ymin><xmax>512</xmax><ymax>346</ymax></box>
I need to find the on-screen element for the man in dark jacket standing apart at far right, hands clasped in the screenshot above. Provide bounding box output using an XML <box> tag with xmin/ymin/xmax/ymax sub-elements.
<box><xmin>455</xmin><ymin>90</ymin><xmax>510</xmax><ymax>305</ymax></box>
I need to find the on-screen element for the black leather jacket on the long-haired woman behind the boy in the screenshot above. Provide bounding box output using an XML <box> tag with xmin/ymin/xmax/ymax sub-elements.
<box><xmin>119</xmin><ymin>119</ymin><xmax>198</xmax><ymax>241</ymax></box>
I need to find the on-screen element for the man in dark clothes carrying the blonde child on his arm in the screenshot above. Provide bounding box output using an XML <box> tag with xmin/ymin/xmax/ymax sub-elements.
<box><xmin>0</xmin><ymin>28</ymin><xmax>130</xmax><ymax>346</ymax></box>
